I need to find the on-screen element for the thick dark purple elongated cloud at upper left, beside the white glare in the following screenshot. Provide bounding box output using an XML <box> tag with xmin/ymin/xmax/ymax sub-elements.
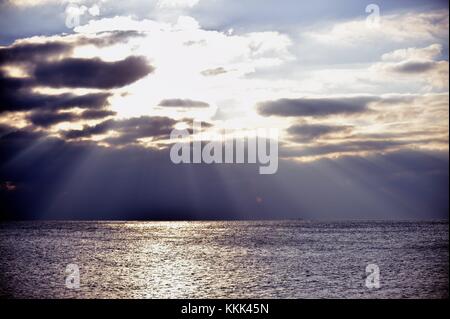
<box><xmin>34</xmin><ymin>56</ymin><xmax>154</xmax><ymax>89</ymax></box>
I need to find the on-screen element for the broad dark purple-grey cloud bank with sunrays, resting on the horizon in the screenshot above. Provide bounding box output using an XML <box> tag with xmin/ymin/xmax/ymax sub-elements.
<box><xmin>0</xmin><ymin>127</ymin><xmax>448</xmax><ymax>220</ymax></box>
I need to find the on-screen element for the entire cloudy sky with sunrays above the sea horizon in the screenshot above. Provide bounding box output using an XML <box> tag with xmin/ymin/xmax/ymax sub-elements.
<box><xmin>0</xmin><ymin>0</ymin><xmax>449</xmax><ymax>220</ymax></box>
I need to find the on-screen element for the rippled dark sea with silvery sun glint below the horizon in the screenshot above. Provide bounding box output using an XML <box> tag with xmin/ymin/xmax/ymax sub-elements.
<box><xmin>0</xmin><ymin>221</ymin><xmax>449</xmax><ymax>298</ymax></box>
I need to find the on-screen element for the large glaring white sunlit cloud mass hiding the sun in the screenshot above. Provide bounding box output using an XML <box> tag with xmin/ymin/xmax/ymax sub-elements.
<box><xmin>68</xmin><ymin>16</ymin><xmax>293</xmax><ymax>122</ymax></box>
